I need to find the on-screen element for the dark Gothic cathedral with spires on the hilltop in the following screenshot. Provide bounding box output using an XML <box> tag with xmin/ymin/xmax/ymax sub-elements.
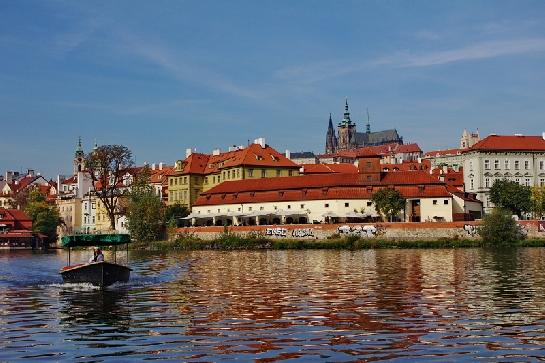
<box><xmin>325</xmin><ymin>100</ymin><xmax>403</xmax><ymax>154</ymax></box>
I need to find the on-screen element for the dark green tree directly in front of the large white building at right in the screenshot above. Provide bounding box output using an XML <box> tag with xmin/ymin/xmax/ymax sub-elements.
<box><xmin>490</xmin><ymin>179</ymin><xmax>532</xmax><ymax>217</ymax></box>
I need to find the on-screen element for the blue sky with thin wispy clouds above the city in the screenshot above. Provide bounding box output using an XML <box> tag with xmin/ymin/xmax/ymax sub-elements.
<box><xmin>0</xmin><ymin>0</ymin><xmax>545</xmax><ymax>177</ymax></box>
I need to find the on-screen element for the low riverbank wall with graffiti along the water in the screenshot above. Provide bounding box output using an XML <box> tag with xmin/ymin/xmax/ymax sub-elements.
<box><xmin>170</xmin><ymin>220</ymin><xmax>545</xmax><ymax>241</ymax></box>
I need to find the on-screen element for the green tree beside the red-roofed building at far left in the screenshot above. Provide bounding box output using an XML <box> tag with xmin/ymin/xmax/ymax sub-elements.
<box><xmin>25</xmin><ymin>189</ymin><xmax>62</xmax><ymax>242</ymax></box>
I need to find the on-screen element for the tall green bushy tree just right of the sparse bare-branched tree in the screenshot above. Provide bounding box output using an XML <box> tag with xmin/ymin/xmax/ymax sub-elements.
<box><xmin>126</xmin><ymin>168</ymin><xmax>164</xmax><ymax>242</ymax></box>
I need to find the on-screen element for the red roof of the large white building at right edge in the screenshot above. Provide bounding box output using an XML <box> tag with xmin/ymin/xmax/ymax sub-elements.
<box><xmin>466</xmin><ymin>135</ymin><xmax>545</xmax><ymax>152</ymax></box>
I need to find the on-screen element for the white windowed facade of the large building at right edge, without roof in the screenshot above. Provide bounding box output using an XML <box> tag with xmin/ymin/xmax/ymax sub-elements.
<box><xmin>463</xmin><ymin>150</ymin><xmax>545</xmax><ymax>212</ymax></box>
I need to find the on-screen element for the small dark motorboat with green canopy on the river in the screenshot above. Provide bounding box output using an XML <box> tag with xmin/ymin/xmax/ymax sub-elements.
<box><xmin>59</xmin><ymin>234</ymin><xmax>132</xmax><ymax>287</ymax></box>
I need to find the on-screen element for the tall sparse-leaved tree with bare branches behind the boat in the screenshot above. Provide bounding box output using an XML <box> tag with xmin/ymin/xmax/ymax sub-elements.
<box><xmin>85</xmin><ymin>145</ymin><xmax>134</xmax><ymax>230</ymax></box>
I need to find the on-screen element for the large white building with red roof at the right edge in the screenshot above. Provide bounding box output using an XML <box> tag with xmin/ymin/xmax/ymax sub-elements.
<box><xmin>463</xmin><ymin>133</ymin><xmax>545</xmax><ymax>212</ymax></box>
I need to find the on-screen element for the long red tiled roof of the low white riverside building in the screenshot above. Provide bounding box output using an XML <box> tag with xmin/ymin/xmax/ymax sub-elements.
<box><xmin>195</xmin><ymin>171</ymin><xmax>450</xmax><ymax>206</ymax></box>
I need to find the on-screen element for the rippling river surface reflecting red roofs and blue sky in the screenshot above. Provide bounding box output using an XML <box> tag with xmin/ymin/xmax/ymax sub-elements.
<box><xmin>0</xmin><ymin>248</ymin><xmax>545</xmax><ymax>362</ymax></box>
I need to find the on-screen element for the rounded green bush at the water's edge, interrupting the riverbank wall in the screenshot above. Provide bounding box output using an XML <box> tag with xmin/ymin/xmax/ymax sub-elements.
<box><xmin>479</xmin><ymin>208</ymin><xmax>525</xmax><ymax>246</ymax></box>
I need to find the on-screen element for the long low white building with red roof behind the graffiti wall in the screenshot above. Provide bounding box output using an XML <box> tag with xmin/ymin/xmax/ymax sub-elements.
<box><xmin>188</xmin><ymin>155</ymin><xmax>453</xmax><ymax>225</ymax></box>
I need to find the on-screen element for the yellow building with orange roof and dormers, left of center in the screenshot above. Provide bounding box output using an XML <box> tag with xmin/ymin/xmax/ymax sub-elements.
<box><xmin>168</xmin><ymin>138</ymin><xmax>300</xmax><ymax>208</ymax></box>
